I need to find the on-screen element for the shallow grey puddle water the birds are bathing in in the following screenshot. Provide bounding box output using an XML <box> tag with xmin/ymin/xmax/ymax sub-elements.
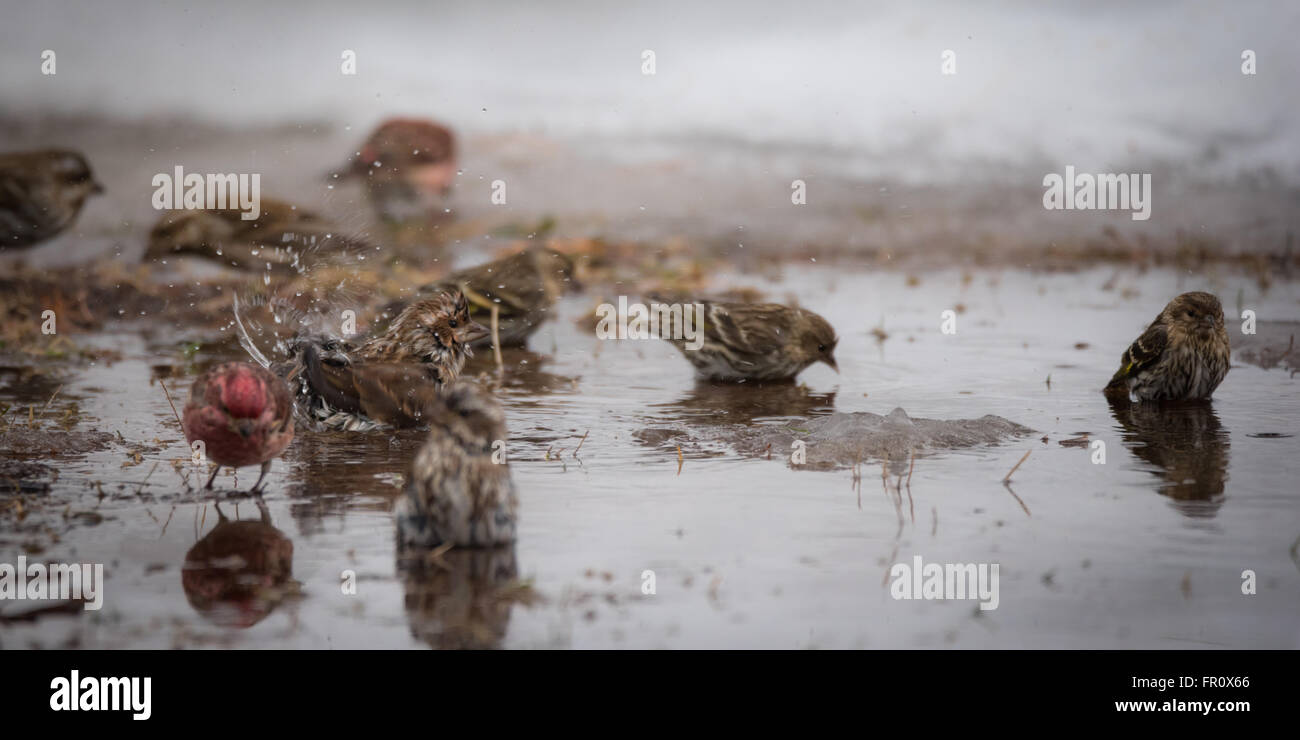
<box><xmin>0</xmin><ymin>264</ymin><xmax>1300</xmax><ymax>648</ymax></box>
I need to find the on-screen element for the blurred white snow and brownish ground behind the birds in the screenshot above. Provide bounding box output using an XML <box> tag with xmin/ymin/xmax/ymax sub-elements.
<box><xmin>0</xmin><ymin>0</ymin><xmax>1300</xmax><ymax>260</ymax></box>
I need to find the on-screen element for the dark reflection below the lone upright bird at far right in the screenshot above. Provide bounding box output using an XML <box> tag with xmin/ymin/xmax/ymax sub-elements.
<box><xmin>1110</xmin><ymin>401</ymin><xmax>1229</xmax><ymax>518</ymax></box>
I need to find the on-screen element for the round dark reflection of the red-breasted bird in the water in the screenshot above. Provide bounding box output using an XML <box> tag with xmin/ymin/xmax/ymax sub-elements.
<box><xmin>181</xmin><ymin>499</ymin><xmax>298</xmax><ymax>629</ymax></box>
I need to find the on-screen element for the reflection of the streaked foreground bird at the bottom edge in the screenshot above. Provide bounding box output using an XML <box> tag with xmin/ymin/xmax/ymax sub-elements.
<box><xmin>398</xmin><ymin>546</ymin><xmax>537</xmax><ymax>650</ymax></box>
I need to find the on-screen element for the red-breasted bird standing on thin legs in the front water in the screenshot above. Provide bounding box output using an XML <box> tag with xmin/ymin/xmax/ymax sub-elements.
<box><xmin>181</xmin><ymin>362</ymin><xmax>294</xmax><ymax>492</ymax></box>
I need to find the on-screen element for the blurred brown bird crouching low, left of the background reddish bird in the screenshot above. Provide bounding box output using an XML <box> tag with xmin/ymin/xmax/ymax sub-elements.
<box><xmin>144</xmin><ymin>198</ymin><xmax>376</xmax><ymax>274</ymax></box>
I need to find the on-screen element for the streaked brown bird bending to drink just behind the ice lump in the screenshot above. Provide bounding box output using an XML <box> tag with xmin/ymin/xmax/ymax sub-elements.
<box><xmin>651</xmin><ymin>297</ymin><xmax>840</xmax><ymax>382</ymax></box>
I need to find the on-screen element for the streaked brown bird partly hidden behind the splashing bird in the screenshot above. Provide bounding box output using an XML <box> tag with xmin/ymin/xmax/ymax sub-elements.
<box><xmin>405</xmin><ymin>247</ymin><xmax>579</xmax><ymax>347</ymax></box>
